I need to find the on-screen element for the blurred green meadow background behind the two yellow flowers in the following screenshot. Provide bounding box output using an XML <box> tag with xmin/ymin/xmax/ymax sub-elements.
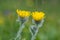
<box><xmin>0</xmin><ymin>0</ymin><xmax>60</xmax><ymax>40</ymax></box>
